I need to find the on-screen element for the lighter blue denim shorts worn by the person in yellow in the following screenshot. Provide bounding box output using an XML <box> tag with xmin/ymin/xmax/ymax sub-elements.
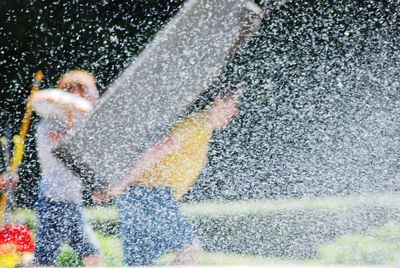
<box><xmin>117</xmin><ymin>185</ymin><xmax>196</xmax><ymax>266</ymax></box>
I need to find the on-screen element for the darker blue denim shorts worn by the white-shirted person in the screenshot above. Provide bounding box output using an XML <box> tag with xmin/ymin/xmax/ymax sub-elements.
<box><xmin>34</xmin><ymin>196</ymin><xmax>99</xmax><ymax>266</ymax></box>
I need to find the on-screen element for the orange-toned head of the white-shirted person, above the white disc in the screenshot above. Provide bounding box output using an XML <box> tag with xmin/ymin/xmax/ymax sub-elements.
<box><xmin>57</xmin><ymin>70</ymin><xmax>99</xmax><ymax>105</ymax></box>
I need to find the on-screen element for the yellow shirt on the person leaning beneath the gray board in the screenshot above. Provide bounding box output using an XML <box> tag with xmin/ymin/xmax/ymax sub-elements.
<box><xmin>139</xmin><ymin>114</ymin><xmax>213</xmax><ymax>199</ymax></box>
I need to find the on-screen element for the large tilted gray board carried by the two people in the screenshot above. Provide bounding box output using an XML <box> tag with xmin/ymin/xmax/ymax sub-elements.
<box><xmin>54</xmin><ymin>0</ymin><xmax>261</xmax><ymax>183</ymax></box>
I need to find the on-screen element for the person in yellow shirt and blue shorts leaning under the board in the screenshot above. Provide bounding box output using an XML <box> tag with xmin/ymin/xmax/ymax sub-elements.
<box><xmin>95</xmin><ymin>89</ymin><xmax>238</xmax><ymax>266</ymax></box>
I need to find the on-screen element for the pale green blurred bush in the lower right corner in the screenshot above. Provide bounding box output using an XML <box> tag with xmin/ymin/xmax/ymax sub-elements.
<box><xmin>319</xmin><ymin>221</ymin><xmax>400</xmax><ymax>265</ymax></box>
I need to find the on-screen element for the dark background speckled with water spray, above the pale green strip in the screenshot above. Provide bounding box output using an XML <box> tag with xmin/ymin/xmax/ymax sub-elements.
<box><xmin>0</xmin><ymin>0</ymin><xmax>400</xmax><ymax>206</ymax></box>
